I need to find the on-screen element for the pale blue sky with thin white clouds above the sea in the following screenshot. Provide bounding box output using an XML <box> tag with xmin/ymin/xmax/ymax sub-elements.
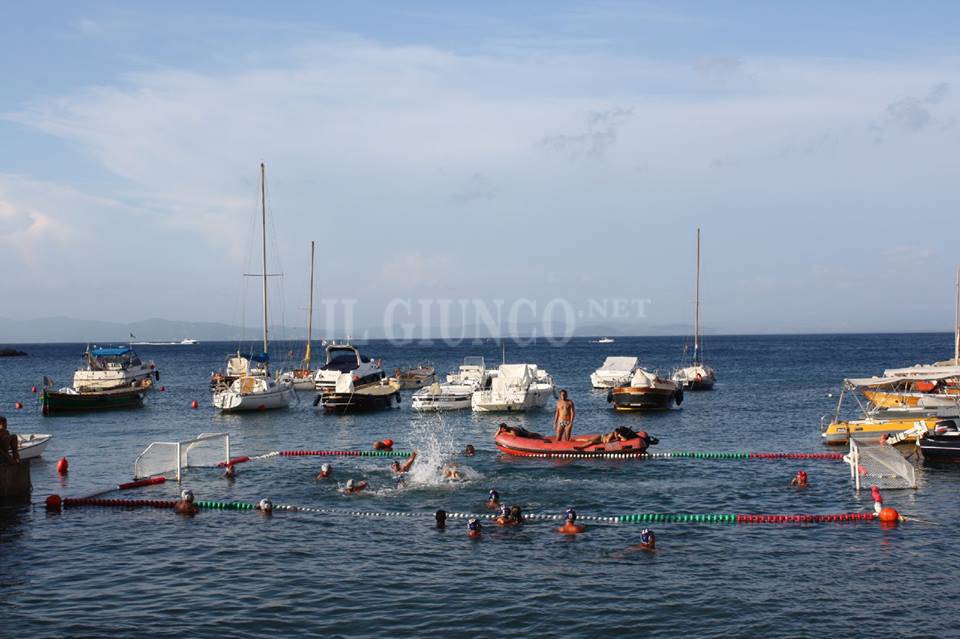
<box><xmin>0</xmin><ymin>0</ymin><xmax>960</xmax><ymax>334</ymax></box>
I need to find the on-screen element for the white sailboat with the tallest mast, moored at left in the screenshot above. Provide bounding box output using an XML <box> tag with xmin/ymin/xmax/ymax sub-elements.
<box><xmin>213</xmin><ymin>162</ymin><xmax>296</xmax><ymax>413</ymax></box>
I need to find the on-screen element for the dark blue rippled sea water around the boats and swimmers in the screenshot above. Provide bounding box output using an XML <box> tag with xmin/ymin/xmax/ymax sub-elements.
<box><xmin>0</xmin><ymin>335</ymin><xmax>960</xmax><ymax>637</ymax></box>
